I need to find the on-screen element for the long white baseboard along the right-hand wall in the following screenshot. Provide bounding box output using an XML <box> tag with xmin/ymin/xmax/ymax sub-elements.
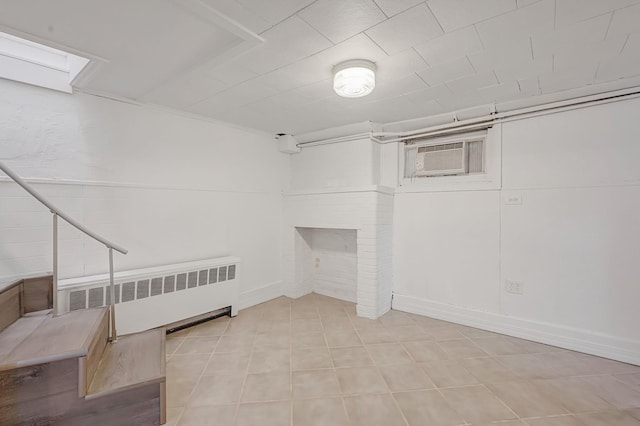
<box><xmin>392</xmin><ymin>293</ymin><xmax>640</xmax><ymax>365</ymax></box>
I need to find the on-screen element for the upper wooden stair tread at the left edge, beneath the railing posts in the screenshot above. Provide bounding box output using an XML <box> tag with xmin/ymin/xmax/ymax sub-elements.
<box><xmin>0</xmin><ymin>308</ymin><xmax>107</xmax><ymax>371</ymax></box>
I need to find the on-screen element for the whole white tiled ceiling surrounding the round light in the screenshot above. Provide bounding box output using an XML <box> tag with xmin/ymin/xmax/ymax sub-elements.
<box><xmin>0</xmin><ymin>0</ymin><xmax>640</xmax><ymax>134</ymax></box>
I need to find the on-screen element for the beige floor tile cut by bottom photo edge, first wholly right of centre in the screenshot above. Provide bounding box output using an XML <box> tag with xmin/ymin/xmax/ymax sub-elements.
<box><xmin>344</xmin><ymin>394</ymin><xmax>406</xmax><ymax>426</ymax></box>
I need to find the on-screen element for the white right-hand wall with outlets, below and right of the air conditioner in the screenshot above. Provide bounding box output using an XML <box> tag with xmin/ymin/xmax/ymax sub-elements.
<box><xmin>393</xmin><ymin>99</ymin><xmax>640</xmax><ymax>364</ymax></box>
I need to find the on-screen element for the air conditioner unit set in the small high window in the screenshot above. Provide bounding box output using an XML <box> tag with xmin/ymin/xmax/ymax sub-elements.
<box><xmin>415</xmin><ymin>142</ymin><xmax>467</xmax><ymax>176</ymax></box>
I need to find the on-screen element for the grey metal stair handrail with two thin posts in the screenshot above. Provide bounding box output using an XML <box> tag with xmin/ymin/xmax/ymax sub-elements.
<box><xmin>0</xmin><ymin>161</ymin><xmax>127</xmax><ymax>343</ymax></box>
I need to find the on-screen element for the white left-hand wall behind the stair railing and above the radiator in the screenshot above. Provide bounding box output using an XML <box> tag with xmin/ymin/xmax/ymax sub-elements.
<box><xmin>0</xmin><ymin>80</ymin><xmax>289</xmax><ymax>306</ymax></box>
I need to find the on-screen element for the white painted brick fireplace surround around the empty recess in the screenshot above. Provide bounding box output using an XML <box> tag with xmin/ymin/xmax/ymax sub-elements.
<box><xmin>283</xmin><ymin>186</ymin><xmax>393</xmax><ymax>318</ymax></box>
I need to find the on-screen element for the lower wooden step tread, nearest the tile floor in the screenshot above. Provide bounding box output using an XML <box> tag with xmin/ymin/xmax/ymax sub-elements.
<box><xmin>85</xmin><ymin>329</ymin><xmax>165</xmax><ymax>399</ymax></box>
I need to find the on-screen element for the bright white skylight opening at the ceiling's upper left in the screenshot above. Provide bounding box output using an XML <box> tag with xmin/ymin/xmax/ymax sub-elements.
<box><xmin>0</xmin><ymin>32</ymin><xmax>89</xmax><ymax>93</ymax></box>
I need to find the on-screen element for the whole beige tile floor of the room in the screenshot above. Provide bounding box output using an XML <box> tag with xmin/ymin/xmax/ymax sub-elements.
<box><xmin>167</xmin><ymin>294</ymin><xmax>640</xmax><ymax>426</ymax></box>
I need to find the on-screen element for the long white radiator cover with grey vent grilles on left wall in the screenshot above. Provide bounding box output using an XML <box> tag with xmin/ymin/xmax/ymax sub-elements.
<box><xmin>58</xmin><ymin>257</ymin><xmax>240</xmax><ymax>335</ymax></box>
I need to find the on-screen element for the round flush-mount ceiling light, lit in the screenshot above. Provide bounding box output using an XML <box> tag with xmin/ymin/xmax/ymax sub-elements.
<box><xmin>333</xmin><ymin>59</ymin><xmax>376</xmax><ymax>98</ymax></box>
